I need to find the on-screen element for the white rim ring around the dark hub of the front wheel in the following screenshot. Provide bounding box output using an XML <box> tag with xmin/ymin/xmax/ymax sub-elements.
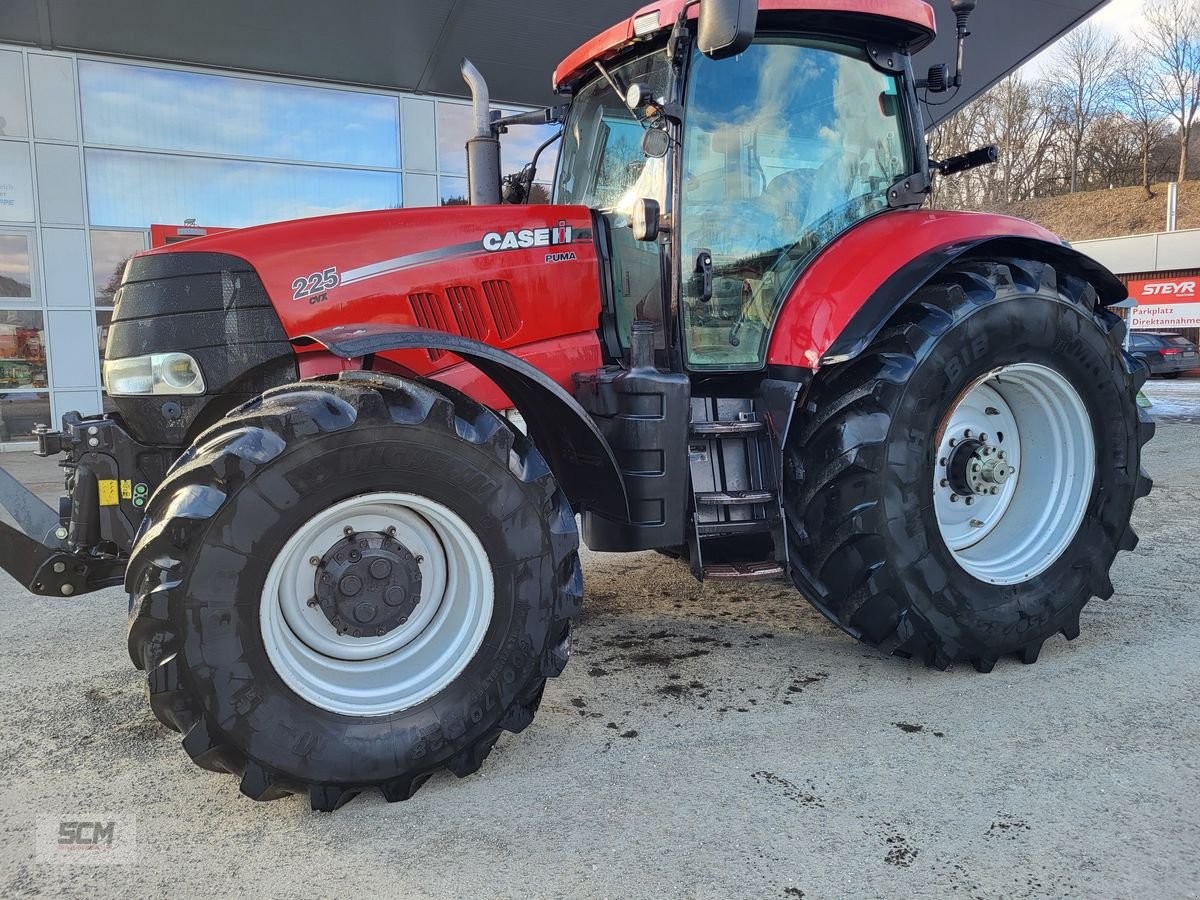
<box><xmin>260</xmin><ymin>492</ymin><xmax>494</xmax><ymax>716</ymax></box>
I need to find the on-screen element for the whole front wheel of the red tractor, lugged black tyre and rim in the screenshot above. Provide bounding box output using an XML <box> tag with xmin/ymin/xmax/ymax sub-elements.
<box><xmin>127</xmin><ymin>373</ymin><xmax>583</xmax><ymax>810</ymax></box>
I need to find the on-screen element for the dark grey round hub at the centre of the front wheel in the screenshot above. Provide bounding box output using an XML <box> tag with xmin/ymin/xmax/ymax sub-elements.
<box><xmin>310</xmin><ymin>532</ymin><xmax>421</xmax><ymax>637</ymax></box>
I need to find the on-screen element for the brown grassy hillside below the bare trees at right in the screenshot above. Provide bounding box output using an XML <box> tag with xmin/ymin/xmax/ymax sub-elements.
<box><xmin>969</xmin><ymin>181</ymin><xmax>1200</xmax><ymax>241</ymax></box>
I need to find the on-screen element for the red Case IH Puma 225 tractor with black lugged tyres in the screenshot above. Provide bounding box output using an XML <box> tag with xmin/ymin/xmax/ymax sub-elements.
<box><xmin>2</xmin><ymin>0</ymin><xmax>1153</xmax><ymax>809</ymax></box>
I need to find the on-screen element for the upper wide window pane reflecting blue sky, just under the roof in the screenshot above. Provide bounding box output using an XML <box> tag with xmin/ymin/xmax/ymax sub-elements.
<box><xmin>79</xmin><ymin>60</ymin><xmax>400</xmax><ymax>168</ymax></box>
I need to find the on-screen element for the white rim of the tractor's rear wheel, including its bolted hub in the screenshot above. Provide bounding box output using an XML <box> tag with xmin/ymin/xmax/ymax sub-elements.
<box><xmin>934</xmin><ymin>362</ymin><xmax>1096</xmax><ymax>584</ymax></box>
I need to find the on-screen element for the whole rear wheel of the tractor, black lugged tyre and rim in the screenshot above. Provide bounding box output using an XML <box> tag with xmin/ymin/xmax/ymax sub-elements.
<box><xmin>785</xmin><ymin>259</ymin><xmax>1154</xmax><ymax>671</ymax></box>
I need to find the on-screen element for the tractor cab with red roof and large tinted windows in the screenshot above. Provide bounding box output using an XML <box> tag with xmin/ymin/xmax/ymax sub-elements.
<box><xmin>554</xmin><ymin>0</ymin><xmax>934</xmax><ymax>373</ymax></box>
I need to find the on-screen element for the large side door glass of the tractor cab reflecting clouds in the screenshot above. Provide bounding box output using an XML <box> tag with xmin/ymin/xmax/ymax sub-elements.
<box><xmin>679</xmin><ymin>36</ymin><xmax>913</xmax><ymax>370</ymax></box>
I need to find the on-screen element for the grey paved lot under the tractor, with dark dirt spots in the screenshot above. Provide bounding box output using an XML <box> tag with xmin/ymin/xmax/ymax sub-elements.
<box><xmin>0</xmin><ymin>425</ymin><xmax>1200</xmax><ymax>898</ymax></box>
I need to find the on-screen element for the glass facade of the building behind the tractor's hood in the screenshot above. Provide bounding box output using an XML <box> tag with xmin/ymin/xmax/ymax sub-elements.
<box><xmin>0</xmin><ymin>46</ymin><xmax>557</xmax><ymax>445</ymax></box>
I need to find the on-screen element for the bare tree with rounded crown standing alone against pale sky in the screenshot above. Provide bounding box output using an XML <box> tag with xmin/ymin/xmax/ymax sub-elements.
<box><xmin>1048</xmin><ymin>24</ymin><xmax>1120</xmax><ymax>193</ymax></box>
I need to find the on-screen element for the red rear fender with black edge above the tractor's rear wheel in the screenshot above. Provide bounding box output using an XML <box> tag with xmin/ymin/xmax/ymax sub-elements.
<box><xmin>767</xmin><ymin>210</ymin><xmax>1126</xmax><ymax>368</ymax></box>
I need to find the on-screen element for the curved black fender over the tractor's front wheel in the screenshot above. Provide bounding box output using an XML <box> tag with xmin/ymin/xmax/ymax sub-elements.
<box><xmin>305</xmin><ymin>325</ymin><xmax>629</xmax><ymax>522</ymax></box>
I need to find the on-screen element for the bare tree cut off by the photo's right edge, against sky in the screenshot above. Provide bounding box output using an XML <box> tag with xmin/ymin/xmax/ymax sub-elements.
<box><xmin>1140</xmin><ymin>0</ymin><xmax>1200</xmax><ymax>181</ymax></box>
